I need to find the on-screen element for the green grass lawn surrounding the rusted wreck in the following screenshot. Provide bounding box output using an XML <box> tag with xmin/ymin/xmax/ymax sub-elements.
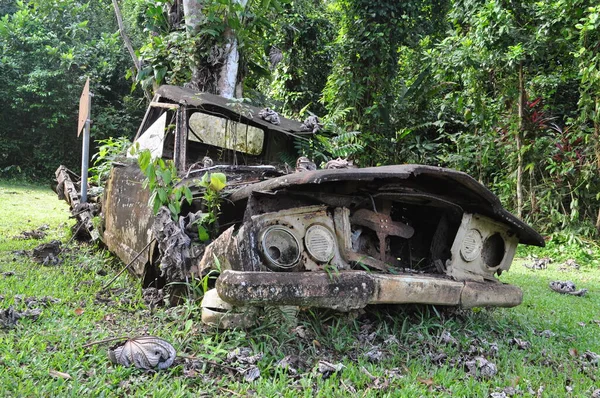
<box><xmin>0</xmin><ymin>183</ymin><xmax>600</xmax><ymax>397</ymax></box>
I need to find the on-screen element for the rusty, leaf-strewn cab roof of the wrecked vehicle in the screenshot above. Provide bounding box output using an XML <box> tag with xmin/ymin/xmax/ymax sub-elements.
<box><xmin>156</xmin><ymin>85</ymin><xmax>312</xmax><ymax>135</ymax></box>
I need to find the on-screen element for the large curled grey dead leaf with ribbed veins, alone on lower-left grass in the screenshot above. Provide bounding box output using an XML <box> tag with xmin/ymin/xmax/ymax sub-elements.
<box><xmin>108</xmin><ymin>336</ymin><xmax>177</xmax><ymax>370</ymax></box>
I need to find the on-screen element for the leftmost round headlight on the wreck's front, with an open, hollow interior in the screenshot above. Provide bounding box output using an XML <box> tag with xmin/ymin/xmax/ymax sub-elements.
<box><xmin>261</xmin><ymin>225</ymin><xmax>300</xmax><ymax>269</ymax></box>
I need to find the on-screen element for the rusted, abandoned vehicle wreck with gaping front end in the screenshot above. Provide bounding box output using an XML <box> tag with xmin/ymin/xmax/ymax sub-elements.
<box><xmin>57</xmin><ymin>86</ymin><xmax>544</xmax><ymax>322</ymax></box>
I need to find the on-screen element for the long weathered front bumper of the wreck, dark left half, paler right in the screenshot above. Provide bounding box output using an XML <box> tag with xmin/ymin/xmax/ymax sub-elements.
<box><xmin>216</xmin><ymin>270</ymin><xmax>523</xmax><ymax>311</ymax></box>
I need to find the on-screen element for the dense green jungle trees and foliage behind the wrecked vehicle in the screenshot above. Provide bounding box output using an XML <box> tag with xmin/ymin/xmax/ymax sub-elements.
<box><xmin>0</xmin><ymin>0</ymin><xmax>600</xmax><ymax>237</ymax></box>
